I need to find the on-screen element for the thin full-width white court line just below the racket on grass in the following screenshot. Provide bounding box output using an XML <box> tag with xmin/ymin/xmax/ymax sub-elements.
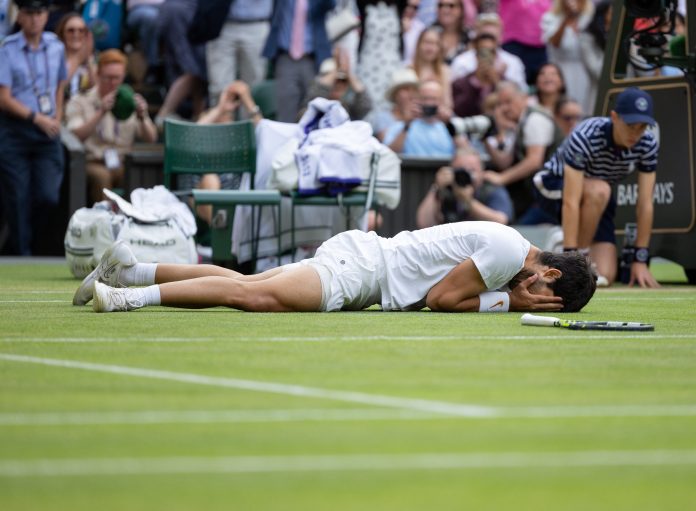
<box><xmin>0</xmin><ymin>327</ymin><xmax>696</xmax><ymax>344</ymax></box>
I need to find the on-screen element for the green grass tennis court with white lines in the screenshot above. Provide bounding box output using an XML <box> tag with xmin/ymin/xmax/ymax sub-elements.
<box><xmin>0</xmin><ymin>263</ymin><xmax>696</xmax><ymax>511</ymax></box>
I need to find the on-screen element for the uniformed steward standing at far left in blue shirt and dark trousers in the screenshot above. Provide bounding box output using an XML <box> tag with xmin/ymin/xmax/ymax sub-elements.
<box><xmin>0</xmin><ymin>0</ymin><xmax>67</xmax><ymax>255</ymax></box>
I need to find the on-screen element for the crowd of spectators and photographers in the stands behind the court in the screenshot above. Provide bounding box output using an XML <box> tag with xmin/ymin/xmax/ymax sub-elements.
<box><xmin>0</xmin><ymin>0</ymin><xmax>684</xmax><ymax>254</ymax></box>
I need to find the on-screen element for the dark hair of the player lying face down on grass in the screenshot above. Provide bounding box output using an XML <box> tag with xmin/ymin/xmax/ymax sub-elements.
<box><xmin>539</xmin><ymin>252</ymin><xmax>597</xmax><ymax>312</ymax></box>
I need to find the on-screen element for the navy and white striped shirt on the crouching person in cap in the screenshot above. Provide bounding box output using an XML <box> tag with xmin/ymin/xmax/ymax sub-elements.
<box><xmin>544</xmin><ymin>117</ymin><xmax>659</xmax><ymax>184</ymax></box>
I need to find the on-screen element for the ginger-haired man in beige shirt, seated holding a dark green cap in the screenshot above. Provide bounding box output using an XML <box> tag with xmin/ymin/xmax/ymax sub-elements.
<box><xmin>65</xmin><ymin>49</ymin><xmax>157</xmax><ymax>206</ymax></box>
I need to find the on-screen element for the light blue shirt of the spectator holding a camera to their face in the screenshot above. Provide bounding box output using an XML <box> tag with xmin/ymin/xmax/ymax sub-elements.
<box><xmin>384</xmin><ymin>119</ymin><xmax>455</xmax><ymax>158</ymax></box>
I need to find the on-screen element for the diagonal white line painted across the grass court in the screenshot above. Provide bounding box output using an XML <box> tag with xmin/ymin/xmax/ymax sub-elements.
<box><xmin>0</xmin><ymin>353</ymin><xmax>494</xmax><ymax>417</ymax></box>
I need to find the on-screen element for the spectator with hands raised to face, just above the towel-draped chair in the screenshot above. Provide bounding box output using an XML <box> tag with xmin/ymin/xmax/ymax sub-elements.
<box><xmin>304</xmin><ymin>47</ymin><xmax>372</xmax><ymax>120</ymax></box>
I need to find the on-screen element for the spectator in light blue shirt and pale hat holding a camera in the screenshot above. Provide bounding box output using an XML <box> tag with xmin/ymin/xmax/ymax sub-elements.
<box><xmin>384</xmin><ymin>80</ymin><xmax>466</xmax><ymax>158</ymax></box>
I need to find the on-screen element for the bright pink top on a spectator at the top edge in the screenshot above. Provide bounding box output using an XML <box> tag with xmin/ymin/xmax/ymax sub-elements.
<box><xmin>499</xmin><ymin>0</ymin><xmax>553</xmax><ymax>47</ymax></box>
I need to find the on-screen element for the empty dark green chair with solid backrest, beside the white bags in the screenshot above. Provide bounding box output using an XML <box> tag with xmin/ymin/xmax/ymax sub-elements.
<box><xmin>164</xmin><ymin>119</ymin><xmax>281</xmax><ymax>265</ymax></box>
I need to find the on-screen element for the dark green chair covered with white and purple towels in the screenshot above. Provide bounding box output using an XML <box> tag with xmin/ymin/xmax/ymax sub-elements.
<box><xmin>290</xmin><ymin>153</ymin><xmax>379</xmax><ymax>260</ymax></box>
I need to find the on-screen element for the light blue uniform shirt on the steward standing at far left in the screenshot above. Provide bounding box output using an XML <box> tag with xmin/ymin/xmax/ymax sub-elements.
<box><xmin>0</xmin><ymin>31</ymin><xmax>68</xmax><ymax>113</ymax></box>
